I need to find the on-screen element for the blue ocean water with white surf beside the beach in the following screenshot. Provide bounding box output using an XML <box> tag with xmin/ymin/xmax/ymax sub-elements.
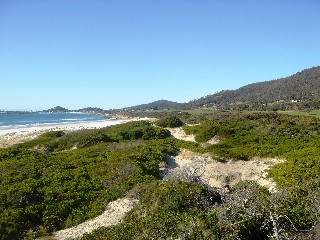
<box><xmin>0</xmin><ymin>113</ymin><xmax>106</xmax><ymax>129</ymax></box>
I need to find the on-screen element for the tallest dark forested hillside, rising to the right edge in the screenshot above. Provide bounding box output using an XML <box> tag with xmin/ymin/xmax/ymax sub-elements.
<box><xmin>184</xmin><ymin>66</ymin><xmax>320</xmax><ymax>110</ymax></box>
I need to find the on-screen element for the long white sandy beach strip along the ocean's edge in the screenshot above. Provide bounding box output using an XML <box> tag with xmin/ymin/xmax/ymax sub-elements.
<box><xmin>0</xmin><ymin>119</ymin><xmax>139</xmax><ymax>148</ymax></box>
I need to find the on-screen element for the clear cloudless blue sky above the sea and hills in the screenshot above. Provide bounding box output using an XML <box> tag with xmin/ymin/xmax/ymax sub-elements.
<box><xmin>0</xmin><ymin>0</ymin><xmax>320</xmax><ymax>110</ymax></box>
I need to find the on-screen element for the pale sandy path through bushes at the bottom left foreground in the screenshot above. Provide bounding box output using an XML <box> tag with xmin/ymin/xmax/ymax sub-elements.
<box><xmin>53</xmin><ymin>198</ymin><xmax>137</xmax><ymax>240</ymax></box>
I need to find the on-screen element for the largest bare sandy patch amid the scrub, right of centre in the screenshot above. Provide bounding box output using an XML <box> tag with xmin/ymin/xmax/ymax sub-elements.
<box><xmin>165</xmin><ymin>150</ymin><xmax>284</xmax><ymax>191</ymax></box>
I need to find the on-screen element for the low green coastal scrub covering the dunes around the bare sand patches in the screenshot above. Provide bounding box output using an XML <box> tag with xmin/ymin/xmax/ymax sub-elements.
<box><xmin>0</xmin><ymin>113</ymin><xmax>320</xmax><ymax>240</ymax></box>
